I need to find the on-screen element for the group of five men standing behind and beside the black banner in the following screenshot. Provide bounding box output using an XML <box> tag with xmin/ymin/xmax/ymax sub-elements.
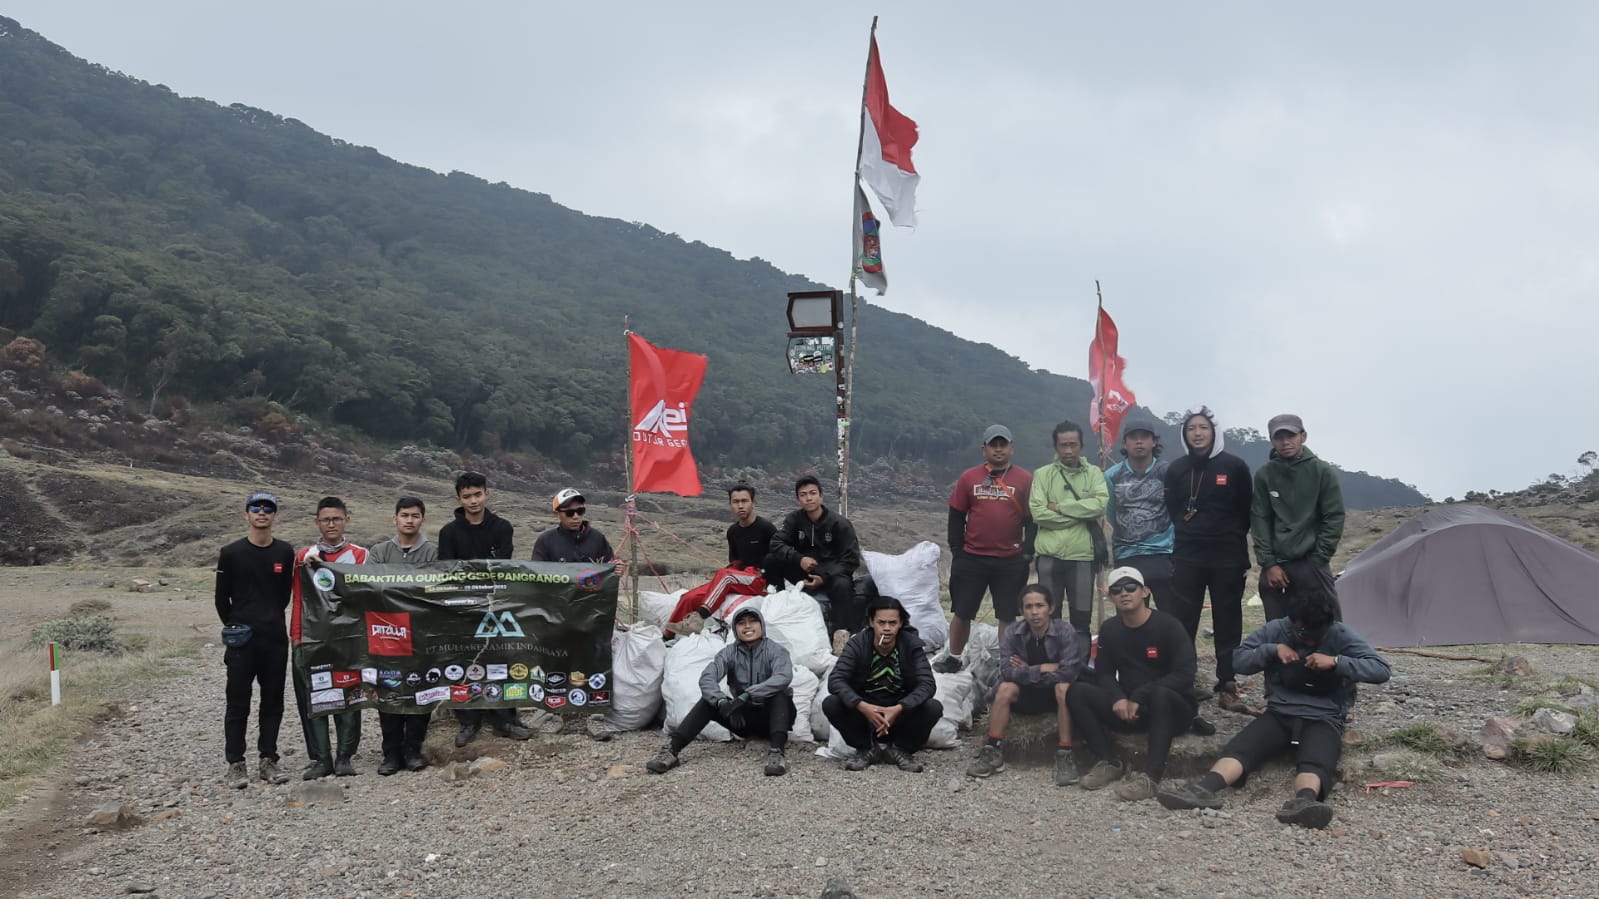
<box><xmin>216</xmin><ymin>472</ymin><xmax>620</xmax><ymax>787</ymax></box>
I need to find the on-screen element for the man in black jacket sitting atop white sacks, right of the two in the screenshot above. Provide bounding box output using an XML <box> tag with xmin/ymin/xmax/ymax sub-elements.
<box><xmin>769</xmin><ymin>475</ymin><xmax>860</xmax><ymax>636</ymax></box>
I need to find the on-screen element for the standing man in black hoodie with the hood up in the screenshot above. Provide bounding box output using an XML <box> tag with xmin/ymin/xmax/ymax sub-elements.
<box><xmin>1161</xmin><ymin>406</ymin><xmax>1254</xmax><ymax>713</ymax></box>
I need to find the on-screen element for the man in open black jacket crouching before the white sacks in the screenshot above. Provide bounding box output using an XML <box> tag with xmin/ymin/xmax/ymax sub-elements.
<box><xmin>822</xmin><ymin>597</ymin><xmax>943</xmax><ymax>773</ymax></box>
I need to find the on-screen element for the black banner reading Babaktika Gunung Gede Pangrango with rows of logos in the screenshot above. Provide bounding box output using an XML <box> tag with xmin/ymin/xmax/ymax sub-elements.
<box><xmin>299</xmin><ymin>560</ymin><xmax>617</xmax><ymax>715</ymax></box>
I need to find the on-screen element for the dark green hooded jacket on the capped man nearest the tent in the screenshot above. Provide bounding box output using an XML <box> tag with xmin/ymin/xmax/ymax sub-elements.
<box><xmin>1249</xmin><ymin>448</ymin><xmax>1343</xmax><ymax>569</ymax></box>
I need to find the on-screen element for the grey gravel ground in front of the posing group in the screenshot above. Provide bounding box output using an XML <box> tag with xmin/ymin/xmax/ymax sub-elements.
<box><xmin>12</xmin><ymin>646</ymin><xmax>1599</xmax><ymax>897</ymax></box>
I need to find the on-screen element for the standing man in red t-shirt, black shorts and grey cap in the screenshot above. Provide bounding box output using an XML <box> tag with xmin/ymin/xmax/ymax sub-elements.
<box><xmin>932</xmin><ymin>424</ymin><xmax>1038</xmax><ymax>673</ymax></box>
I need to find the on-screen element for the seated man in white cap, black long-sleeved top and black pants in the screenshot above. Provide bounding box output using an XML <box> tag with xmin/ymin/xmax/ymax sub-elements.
<box><xmin>1067</xmin><ymin>568</ymin><xmax>1214</xmax><ymax>800</ymax></box>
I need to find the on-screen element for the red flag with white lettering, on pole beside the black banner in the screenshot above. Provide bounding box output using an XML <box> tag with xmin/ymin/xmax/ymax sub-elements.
<box><xmin>627</xmin><ymin>334</ymin><xmax>705</xmax><ymax>496</ymax></box>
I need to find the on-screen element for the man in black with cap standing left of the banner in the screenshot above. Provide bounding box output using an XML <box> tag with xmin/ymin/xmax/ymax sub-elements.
<box><xmin>216</xmin><ymin>489</ymin><xmax>294</xmax><ymax>789</ymax></box>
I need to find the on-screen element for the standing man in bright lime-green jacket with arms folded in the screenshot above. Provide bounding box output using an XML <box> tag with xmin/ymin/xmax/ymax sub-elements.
<box><xmin>1028</xmin><ymin>421</ymin><xmax>1110</xmax><ymax>639</ymax></box>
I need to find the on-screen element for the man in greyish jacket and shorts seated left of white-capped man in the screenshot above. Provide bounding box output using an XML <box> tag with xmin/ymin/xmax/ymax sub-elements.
<box><xmin>966</xmin><ymin>584</ymin><xmax>1083</xmax><ymax>787</ymax></box>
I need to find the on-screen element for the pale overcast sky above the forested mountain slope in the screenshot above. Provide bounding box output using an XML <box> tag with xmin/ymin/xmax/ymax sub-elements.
<box><xmin>0</xmin><ymin>0</ymin><xmax>1599</xmax><ymax>499</ymax></box>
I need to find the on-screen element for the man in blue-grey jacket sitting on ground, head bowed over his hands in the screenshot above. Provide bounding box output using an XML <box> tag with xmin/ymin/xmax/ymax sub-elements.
<box><xmin>1158</xmin><ymin>585</ymin><xmax>1391</xmax><ymax>829</ymax></box>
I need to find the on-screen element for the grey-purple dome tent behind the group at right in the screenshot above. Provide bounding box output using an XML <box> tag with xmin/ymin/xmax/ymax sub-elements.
<box><xmin>1338</xmin><ymin>504</ymin><xmax>1599</xmax><ymax>646</ymax></box>
